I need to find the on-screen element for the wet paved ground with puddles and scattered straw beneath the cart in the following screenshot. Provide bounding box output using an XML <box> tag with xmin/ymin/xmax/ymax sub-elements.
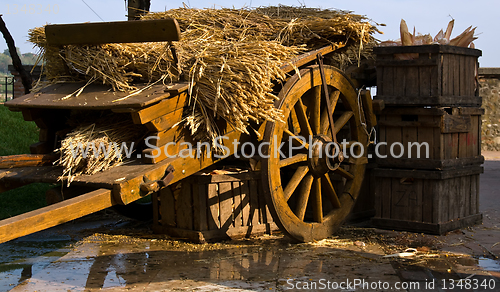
<box><xmin>0</xmin><ymin>153</ymin><xmax>500</xmax><ymax>291</ymax></box>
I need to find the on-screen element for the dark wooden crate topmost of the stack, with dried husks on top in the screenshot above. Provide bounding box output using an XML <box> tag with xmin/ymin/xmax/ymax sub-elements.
<box><xmin>373</xmin><ymin>45</ymin><xmax>481</xmax><ymax>106</ymax></box>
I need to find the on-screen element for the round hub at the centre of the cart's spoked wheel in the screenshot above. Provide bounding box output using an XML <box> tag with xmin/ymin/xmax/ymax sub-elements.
<box><xmin>308</xmin><ymin>135</ymin><xmax>344</xmax><ymax>177</ymax></box>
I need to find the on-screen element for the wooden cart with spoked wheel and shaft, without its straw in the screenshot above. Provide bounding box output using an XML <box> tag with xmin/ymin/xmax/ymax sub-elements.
<box><xmin>0</xmin><ymin>19</ymin><xmax>375</xmax><ymax>242</ymax></box>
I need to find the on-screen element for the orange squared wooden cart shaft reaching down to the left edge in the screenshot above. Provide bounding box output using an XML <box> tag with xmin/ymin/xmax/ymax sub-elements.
<box><xmin>0</xmin><ymin>189</ymin><xmax>112</xmax><ymax>243</ymax></box>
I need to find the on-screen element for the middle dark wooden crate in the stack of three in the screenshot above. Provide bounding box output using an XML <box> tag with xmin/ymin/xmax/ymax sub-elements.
<box><xmin>376</xmin><ymin>107</ymin><xmax>484</xmax><ymax>169</ymax></box>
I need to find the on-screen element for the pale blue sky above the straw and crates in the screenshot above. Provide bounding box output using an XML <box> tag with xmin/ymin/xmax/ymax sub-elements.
<box><xmin>0</xmin><ymin>0</ymin><xmax>500</xmax><ymax>67</ymax></box>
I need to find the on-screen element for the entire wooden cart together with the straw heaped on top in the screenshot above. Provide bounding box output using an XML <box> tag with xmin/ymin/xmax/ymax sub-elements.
<box><xmin>0</xmin><ymin>8</ymin><xmax>374</xmax><ymax>241</ymax></box>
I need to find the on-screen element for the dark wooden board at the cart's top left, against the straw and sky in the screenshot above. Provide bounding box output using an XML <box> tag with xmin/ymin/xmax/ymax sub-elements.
<box><xmin>45</xmin><ymin>18</ymin><xmax>181</xmax><ymax>46</ymax></box>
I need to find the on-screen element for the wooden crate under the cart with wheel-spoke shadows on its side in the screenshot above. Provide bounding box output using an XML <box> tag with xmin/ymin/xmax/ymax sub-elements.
<box><xmin>153</xmin><ymin>172</ymin><xmax>278</xmax><ymax>243</ymax></box>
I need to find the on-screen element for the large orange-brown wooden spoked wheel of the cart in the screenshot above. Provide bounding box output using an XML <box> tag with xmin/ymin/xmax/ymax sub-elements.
<box><xmin>262</xmin><ymin>66</ymin><xmax>367</xmax><ymax>242</ymax></box>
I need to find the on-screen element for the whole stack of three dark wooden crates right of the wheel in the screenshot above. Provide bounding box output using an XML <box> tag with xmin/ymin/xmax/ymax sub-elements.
<box><xmin>372</xmin><ymin>45</ymin><xmax>484</xmax><ymax>234</ymax></box>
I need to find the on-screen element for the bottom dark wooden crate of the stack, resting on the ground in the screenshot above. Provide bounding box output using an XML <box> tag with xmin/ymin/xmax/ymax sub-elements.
<box><xmin>371</xmin><ymin>166</ymin><xmax>483</xmax><ymax>234</ymax></box>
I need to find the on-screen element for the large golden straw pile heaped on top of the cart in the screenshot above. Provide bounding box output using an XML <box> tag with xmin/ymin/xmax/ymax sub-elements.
<box><xmin>30</xmin><ymin>6</ymin><xmax>377</xmax><ymax>145</ymax></box>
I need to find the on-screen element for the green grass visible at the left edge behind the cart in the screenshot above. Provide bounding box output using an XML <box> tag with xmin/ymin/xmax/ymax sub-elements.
<box><xmin>0</xmin><ymin>104</ymin><xmax>53</xmax><ymax>219</ymax></box>
